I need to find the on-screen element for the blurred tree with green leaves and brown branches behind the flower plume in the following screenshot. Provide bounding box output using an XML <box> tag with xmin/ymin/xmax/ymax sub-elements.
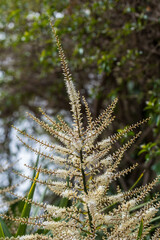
<box><xmin>0</xmin><ymin>0</ymin><xmax>160</xmax><ymax>189</ymax></box>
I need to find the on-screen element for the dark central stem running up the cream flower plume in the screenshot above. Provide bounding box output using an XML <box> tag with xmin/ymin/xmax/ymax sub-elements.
<box><xmin>80</xmin><ymin>149</ymin><xmax>93</xmax><ymax>231</ymax></box>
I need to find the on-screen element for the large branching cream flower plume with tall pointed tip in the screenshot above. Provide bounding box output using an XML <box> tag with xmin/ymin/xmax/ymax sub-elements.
<box><xmin>2</xmin><ymin>23</ymin><xmax>160</xmax><ymax>240</ymax></box>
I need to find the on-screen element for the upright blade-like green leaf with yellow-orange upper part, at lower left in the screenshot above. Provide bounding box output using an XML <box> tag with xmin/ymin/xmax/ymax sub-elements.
<box><xmin>16</xmin><ymin>172</ymin><xmax>39</xmax><ymax>237</ymax></box>
